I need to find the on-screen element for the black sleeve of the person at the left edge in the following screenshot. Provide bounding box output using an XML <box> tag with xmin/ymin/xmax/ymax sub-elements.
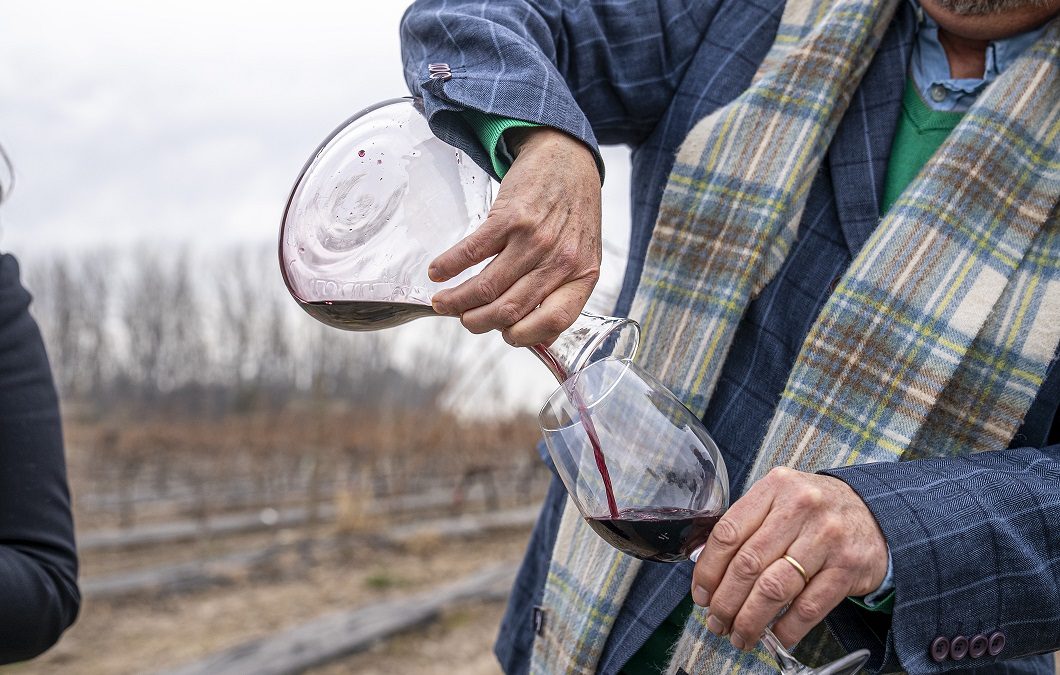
<box><xmin>0</xmin><ymin>255</ymin><xmax>81</xmax><ymax>663</ymax></box>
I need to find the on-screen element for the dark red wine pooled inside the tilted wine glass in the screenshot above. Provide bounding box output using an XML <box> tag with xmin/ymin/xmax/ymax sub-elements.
<box><xmin>585</xmin><ymin>508</ymin><xmax>721</xmax><ymax>563</ymax></box>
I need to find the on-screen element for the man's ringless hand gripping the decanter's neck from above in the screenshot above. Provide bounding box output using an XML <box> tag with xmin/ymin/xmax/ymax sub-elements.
<box><xmin>427</xmin><ymin>127</ymin><xmax>600</xmax><ymax>347</ymax></box>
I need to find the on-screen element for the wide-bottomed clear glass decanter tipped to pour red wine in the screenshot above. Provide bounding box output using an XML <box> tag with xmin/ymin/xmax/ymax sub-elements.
<box><xmin>280</xmin><ymin>97</ymin><xmax>640</xmax><ymax>381</ymax></box>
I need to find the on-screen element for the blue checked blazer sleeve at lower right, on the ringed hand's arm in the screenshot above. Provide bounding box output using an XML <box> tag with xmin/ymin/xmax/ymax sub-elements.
<box><xmin>823</xmin><ymin>445</ymin><xmax>1060</xmax><ymax>673</ymax></box>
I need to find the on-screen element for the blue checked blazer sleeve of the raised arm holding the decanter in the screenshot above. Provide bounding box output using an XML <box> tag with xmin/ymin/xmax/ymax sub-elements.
<box><xmin>401</xmin><ymin>0</ymin><xmax>718</xmax><ymax>179</ymax></box>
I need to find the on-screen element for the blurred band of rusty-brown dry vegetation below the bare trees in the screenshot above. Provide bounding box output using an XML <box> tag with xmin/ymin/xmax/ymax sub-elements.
<box><xmin>66</xmin><ymin>407</ymin><xmax>542</xmax><ymax>531</ymax></box>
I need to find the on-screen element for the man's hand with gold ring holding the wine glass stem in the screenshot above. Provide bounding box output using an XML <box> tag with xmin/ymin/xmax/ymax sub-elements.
<box><xmin>692</xmin><ymin>468</ymin><xmax>887</xmax><ymax>650</ymax></box>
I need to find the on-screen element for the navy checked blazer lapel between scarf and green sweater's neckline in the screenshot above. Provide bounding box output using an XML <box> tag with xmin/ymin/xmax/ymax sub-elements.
<box><xmin>827</xmin><ymin>4</ymin><xmax>917</xmax><ymax>256</ymax></box>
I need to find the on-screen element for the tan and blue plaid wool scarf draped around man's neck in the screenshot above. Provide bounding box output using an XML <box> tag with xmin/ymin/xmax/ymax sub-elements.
<box><xmin>532</xmin><ymin>0</ymin><xmax>1060</xmax><ymax>675</ymax></box>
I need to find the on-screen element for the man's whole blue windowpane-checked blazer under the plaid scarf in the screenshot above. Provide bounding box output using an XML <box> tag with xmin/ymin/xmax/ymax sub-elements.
<box><xmin>401</xmin><ymin>0</ymin><xmax>1060</xmax><ymax>675</ymax></box>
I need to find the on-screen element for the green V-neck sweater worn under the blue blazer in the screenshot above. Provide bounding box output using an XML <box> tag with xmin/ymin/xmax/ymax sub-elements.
<box><xmin>464</xmin><ymin>77</ymin><xmax>964</xmax><ymax>675</ymax></box>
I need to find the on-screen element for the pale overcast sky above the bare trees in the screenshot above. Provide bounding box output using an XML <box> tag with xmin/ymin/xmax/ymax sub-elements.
<box><xmin>0</xmin><ymin>0</ymin><xmax>629</xmax><ymax>413</ymax></box>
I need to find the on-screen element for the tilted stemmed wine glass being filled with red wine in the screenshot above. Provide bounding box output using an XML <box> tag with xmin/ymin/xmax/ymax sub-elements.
<box><xmin>538</xmin><ymin>357</ymin><xmax>869</xmax><ymax>675</ymax></box>
